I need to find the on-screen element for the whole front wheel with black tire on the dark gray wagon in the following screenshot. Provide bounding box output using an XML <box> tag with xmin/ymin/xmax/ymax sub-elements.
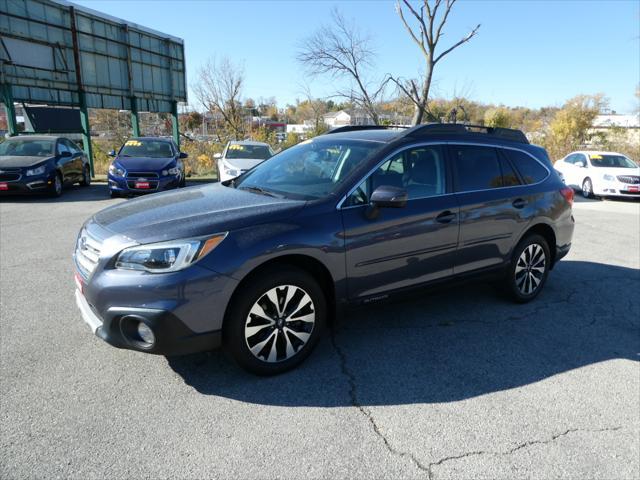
<box><xmin>223</xmin><ymin>267</ymin><xmax>327</xmax><ymax>375</ymax></box>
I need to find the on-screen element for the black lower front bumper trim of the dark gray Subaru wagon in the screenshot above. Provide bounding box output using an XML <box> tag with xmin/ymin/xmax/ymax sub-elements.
<box><xmin>75</xmin><ymin>290</ymin><xmax>222</xmax><ymax>355</ymax></box>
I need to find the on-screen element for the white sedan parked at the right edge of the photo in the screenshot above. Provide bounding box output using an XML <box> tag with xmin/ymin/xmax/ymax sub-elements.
<box><xmin>554</xmin><ymin>151</ymin><xmax>640</xmax><ymax>198</ymax></box>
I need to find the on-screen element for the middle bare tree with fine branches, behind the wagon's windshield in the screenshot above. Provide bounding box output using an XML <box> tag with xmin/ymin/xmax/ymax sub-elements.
<box><xmin>297</xmin><ymin>9</ymin><xmax>387</xmax><ymax>125</ymax></box>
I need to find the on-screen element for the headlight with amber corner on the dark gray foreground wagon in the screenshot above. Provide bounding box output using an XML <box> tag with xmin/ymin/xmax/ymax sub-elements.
<box><xmin>116</xmin><ymin>233</ymin><xmax>227</xmax><ymax>273</ymax></box>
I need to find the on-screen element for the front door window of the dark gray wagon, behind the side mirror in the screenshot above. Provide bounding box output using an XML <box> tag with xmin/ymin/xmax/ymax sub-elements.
<box><xmin>345</xmin><ymin>146</ymin><xmax>446</xmax><ymax>206</ymax></box>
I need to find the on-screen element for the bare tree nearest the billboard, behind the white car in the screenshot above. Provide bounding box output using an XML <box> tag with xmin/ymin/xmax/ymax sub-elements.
<box><xmin>193</xmin><ymin>58</ymin><xmax>244</xmax><ymax>140</ymax></box>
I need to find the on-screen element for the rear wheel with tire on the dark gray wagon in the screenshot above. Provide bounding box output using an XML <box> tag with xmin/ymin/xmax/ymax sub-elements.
<box><xmin>505</xmin><ymin>234</ymin><xmax>551</xmax><ymax>303</ymax></box>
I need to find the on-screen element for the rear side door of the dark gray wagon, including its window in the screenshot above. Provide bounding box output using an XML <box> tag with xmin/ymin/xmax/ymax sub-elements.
<box><xmin>449</xmin><ymin>144</ymin><xmax>535</xmax><ymax>274</ymax></box>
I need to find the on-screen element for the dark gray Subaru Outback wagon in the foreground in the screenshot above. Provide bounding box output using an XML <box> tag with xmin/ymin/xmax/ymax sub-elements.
<box><xmin>74</xmin><ymin>124</ymin><xmax>574</xmax><ymax>374</ymax></box>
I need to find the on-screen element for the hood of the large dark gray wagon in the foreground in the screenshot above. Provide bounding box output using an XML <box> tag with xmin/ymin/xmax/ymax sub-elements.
<box><xmin>93</xmin><ymin>183</ymin><xmax>305</xmax><ymax>243</ymax></box>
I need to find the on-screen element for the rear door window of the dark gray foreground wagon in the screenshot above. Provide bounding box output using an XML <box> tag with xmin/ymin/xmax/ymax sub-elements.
<box><xmin>451</xmin><ymin>145</ymin><xmax>502</xmax><ymax>192</ymax></box>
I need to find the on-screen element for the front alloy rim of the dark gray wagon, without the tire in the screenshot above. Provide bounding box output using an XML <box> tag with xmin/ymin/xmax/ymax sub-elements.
<box><xmin>244</xmin><ymin>285</ymin><xmax>316</xmax><ymax>363</ymax></box>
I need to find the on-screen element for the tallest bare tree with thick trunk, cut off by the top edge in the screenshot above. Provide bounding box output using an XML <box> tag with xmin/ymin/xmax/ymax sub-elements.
<box><xmin>390</xmin><ymin>0</ymin><xmax>480</xmax><ymax>125</ymax></box>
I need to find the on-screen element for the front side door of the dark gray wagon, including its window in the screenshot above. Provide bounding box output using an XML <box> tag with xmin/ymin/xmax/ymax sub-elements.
<box><xmin>342</xmin><ymin>145</ymin><xmax>458</xmax><ymax>299</ymax></box>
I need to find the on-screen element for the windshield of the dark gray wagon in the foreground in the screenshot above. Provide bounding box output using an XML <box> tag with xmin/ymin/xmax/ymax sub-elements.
<box><xmin>235</xmin><ymin>138</ymin><xmax>384</xmax><ymax>200</ymax></box>
